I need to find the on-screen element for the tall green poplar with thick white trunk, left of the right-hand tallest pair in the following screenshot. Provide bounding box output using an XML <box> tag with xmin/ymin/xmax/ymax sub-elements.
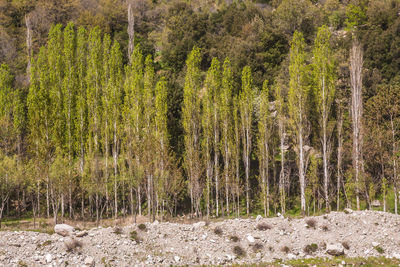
<box><xmin>288</xmin><ymin>31</ymin><xmax>308</xmax><ymax>214</ymax></box>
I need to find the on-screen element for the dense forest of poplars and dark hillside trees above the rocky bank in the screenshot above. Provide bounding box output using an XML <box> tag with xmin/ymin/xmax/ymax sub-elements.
<box><xmin>0</xmin><ymin>0</ymin><xmax>400</xmax><ymax>225</ymax></box>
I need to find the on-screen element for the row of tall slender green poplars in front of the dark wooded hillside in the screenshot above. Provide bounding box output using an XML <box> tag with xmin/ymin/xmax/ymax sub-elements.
<box><xmin>0</xmin><ymin>23</ymin><xmax>400</xmax><ymax>225</ymax></box>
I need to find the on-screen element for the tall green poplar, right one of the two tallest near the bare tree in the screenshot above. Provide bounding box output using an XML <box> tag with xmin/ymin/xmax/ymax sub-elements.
<box><xmin>313</xmin><ymin>26</ymin><xmax>335</xmax><ymax>214</ymax></box>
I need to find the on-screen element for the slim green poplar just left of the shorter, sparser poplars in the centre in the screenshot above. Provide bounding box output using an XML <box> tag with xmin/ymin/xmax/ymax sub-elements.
<box><xmin>239</xmin><ymin>66</ymin><xmax>254</xmax><ymax>216</ymax></box>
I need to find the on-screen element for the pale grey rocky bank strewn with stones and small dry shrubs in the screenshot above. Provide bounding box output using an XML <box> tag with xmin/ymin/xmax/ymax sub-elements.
<box><xmin>0</xmin><ymin>210</ymin><xmax>400</xmax><ymax>266</ymax></box>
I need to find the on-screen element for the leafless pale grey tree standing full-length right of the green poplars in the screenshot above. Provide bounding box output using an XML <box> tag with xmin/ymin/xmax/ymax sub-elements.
<box><xmin>350</xmin><ymin>39</ymin><xmax>363</xmax><ymax>213</ymax></box>
